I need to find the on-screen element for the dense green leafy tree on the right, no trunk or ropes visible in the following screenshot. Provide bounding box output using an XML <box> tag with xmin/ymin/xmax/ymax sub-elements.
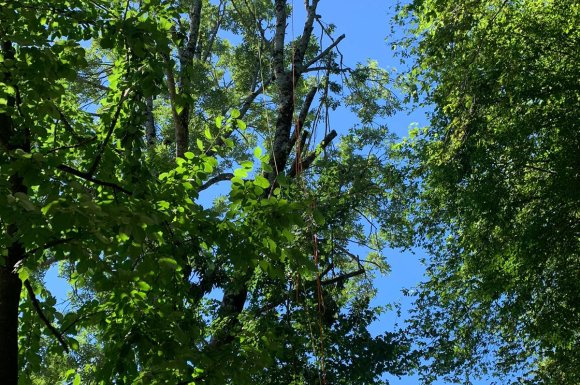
<box><xmin>398</xmin><ymin>0</ymin><xmax>580</xmax><ymax>384</ymax></box>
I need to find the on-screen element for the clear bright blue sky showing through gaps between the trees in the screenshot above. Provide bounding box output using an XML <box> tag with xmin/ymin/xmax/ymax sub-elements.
<box><xmin>47</xmin><ymin>0</ymin><xmax>494</xmax><ymax>385</ymax></box>
